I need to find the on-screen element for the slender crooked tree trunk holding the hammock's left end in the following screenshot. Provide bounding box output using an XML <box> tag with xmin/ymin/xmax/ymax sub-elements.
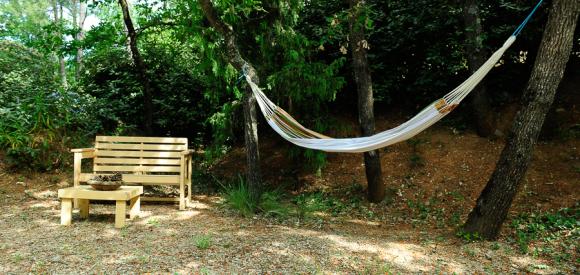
<box><xmin>199</xmin><ymin>0</ymin><xmax>264</xmax><ymax>201</ymax></box>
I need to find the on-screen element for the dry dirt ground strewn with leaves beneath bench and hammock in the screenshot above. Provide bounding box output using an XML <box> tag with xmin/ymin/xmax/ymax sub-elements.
<box><xmin>0</xmin><ymin>126</ymin><xmax>580</xmax><ymax>274</ymax></box>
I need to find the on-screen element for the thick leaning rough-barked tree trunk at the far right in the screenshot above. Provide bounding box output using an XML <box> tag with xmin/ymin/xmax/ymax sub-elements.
<box><xmin>464</xmin><ymin>0</ymin><xmax>580</xmax><ymax>239</ymax></box>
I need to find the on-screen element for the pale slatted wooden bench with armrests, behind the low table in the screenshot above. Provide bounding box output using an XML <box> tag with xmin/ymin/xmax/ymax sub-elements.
<box><xmin>71</xmin><ymin>136</ymin><xmax>193</xmax><ymax>210</ymax></box>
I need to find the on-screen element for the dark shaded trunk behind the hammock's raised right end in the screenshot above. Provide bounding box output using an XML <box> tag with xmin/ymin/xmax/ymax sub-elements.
<box><xmin>463</xmin><ymin>0</ymin><xmax>495</xmax><ymax>137</ymax></box>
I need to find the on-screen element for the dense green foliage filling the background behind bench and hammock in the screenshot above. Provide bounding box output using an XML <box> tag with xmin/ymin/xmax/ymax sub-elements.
<box><xmin>0</xmin><ymin>0</ymin><xmax>545</xmax><ymax>173</ymax></box>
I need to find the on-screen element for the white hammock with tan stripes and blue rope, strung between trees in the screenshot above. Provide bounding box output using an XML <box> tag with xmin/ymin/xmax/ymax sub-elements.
<box><xmin>245</xmin><ymin>0</ymin><xmax>542</xmax><ymax>153</ymax></box>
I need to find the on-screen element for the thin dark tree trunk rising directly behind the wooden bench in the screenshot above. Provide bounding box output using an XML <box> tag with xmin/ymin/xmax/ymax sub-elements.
<box><xmin>119</xmin><ymin>0</ymin><xmax>153</xmax><ymax>135</ymax></box>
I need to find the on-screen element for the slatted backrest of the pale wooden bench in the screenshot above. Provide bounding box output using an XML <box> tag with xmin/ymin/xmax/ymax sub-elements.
<box><xmin>93</xmin><ymin>136</ymin><xmax>187</xmax><ymax>175</ymax></box>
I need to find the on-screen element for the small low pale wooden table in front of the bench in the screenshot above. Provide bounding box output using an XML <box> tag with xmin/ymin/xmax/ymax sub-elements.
<box><xmin>58</xmin><ymin>185</ymin><xmax>143</xmax><ymax>228</ymax></box>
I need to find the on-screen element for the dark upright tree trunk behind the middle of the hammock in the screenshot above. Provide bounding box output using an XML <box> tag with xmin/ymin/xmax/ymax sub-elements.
<box><xmin>350</xmin><ymin>0</ymin><xmax>385</xmax><ymax>202</ymax></box>
